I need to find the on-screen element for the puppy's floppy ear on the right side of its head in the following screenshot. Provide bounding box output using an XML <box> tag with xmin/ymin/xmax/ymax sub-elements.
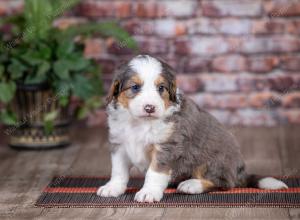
<box><xmin>160</xmin><ymin>60</ymin><xmax>178</xmax><ymax>103</ymax></box>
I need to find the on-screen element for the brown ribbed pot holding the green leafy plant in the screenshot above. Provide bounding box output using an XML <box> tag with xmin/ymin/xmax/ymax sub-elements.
<box><xmin>6</xmin><ymin>84</ymin><xmax>71</xmax><ymax>149</ymax></box>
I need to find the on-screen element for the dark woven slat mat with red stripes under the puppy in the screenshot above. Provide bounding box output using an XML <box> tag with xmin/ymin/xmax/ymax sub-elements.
<box><xmin>35</xmin><ymin>176</ymin><xmax>300</xmax><ymax>208</ymax></box>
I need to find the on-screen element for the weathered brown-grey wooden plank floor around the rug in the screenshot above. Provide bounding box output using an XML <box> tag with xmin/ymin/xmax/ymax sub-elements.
<box><xmin>0</xmin><ymin>125</ymin><xmax>300</xmax><ymax>220</ymax></box>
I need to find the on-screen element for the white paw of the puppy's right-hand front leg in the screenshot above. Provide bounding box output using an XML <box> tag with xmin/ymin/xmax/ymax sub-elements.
<box><xmin>134</xmin><ymin>188</ymin><xmax>163</xmax><ymax>202</ymax></box>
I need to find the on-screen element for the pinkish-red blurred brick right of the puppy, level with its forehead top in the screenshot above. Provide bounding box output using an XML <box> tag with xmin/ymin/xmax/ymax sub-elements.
<box><xmin>183</xmin><ymin>57</ymin><xmax>211</xmax><ymax>73</ymax></box>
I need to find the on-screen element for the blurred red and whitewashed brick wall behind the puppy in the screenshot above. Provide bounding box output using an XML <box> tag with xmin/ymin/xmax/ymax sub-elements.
<box><xmin>0</xmin><ymin>0</ymin><xmax>300</xmax><ymax>125</ymax></box>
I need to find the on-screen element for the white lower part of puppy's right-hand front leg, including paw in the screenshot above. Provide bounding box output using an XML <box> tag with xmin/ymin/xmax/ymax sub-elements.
<box><xmin>134</xmin><ymin>168</ymin><xmax>171</xmax><ymax>202</ymax></box>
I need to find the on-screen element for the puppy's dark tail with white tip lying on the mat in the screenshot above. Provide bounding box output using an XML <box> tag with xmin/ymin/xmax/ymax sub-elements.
<box><xmin>243</xmin><ymin>174</ymin><xmax>288</xmax><ymax>189</ymax></box>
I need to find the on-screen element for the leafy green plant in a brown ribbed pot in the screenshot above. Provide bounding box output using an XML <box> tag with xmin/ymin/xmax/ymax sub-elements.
<box><xmin>0</xmin><ymin>0</ymin><xmax>136</xmax><ymax>148</ymax></box>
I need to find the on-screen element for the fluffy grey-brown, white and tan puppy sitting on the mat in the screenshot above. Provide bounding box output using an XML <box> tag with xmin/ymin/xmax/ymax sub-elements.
<box><xmin>97</xmin><ymin>55</ymin><xmax>287</xmax><ymax>202</ymax></box>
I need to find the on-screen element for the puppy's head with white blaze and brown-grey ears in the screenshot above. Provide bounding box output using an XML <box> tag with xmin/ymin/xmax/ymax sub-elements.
<box><xmin>107</xmin><ymin>55</ymin><xmax>177</xmax><ymax>119</ymax></box>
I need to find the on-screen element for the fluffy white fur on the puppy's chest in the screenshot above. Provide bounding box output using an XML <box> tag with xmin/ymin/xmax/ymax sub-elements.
<box><xmin>108</xmin><ymin>109</ymin><xmax>174</xmax><ymax>172</ymax></box>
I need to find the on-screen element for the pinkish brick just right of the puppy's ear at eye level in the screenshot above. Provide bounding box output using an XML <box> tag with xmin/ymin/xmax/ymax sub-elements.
<box><xmin>177</xmin><ymin>74</ymin><xmax>203</xmax><ymax>93</ymax></box>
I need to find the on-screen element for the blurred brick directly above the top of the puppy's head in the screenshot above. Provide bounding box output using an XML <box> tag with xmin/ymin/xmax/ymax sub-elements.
<box><xmin>137</xmin><ymin>37</ymin><xmax>169</xmax><ymax>54</ymax></box>
